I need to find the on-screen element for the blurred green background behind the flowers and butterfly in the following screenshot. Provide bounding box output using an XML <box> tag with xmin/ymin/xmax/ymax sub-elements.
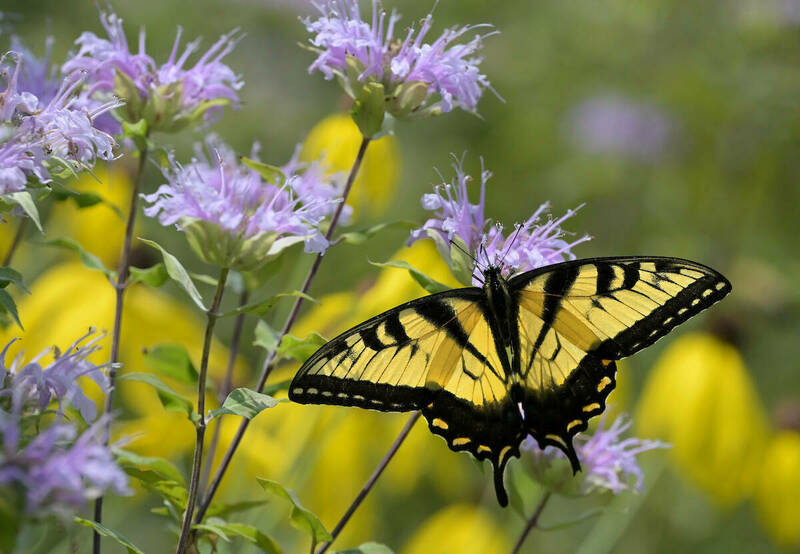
<box><xmin>2</xmin><ymin>0</ymin><xmax>800</xmax><ymax>553</ymax></box>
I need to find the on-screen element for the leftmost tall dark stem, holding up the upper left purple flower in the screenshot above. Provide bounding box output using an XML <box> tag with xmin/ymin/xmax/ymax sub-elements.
<box><xmin>92</xmin><ymin>146</ymin><xmax>147</xmax><ymax>554</ymax></box>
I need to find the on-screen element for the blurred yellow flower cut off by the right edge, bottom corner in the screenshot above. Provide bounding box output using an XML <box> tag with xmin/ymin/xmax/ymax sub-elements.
<box><xmin>755</xmin><ymin>431</ymin><xmax>800</xmax><ymax>547</ymax></box>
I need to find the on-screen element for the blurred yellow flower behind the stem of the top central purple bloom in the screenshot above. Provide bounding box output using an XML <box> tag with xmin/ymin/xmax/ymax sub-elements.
<box><xmin>300</xmin><ymin>114</ymin><xmax>401</xmax><ymax>216</ymax></box>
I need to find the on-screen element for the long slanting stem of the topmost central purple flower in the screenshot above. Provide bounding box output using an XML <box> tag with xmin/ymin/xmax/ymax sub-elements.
<box><xmin>195</xmin><ymin>137</ymin><xmax>370</xmax><ymax>523</ymax></box>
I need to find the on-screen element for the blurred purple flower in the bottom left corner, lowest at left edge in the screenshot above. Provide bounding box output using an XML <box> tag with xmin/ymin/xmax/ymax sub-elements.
<box><xmin>0</xmin><ymin>412</ymin><xmax>130</xmax><ymax>516</ymax></box>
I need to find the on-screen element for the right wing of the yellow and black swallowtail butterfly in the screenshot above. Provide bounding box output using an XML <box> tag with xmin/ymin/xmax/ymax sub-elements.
<box><xmin>509</xmin><ymin>256</ymin><xmax>731</xmax><ymax>471</ymax></box>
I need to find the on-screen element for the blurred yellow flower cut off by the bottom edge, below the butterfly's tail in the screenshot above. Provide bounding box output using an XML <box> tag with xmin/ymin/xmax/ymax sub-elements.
<box><xmin>400</xmin><ymin>504</ymin><xmax>511</xmax><ymax>554</ymax></box>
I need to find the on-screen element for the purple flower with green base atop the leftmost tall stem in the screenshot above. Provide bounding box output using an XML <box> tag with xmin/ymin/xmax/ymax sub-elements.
<box><xmin>63</xmin><ymin>12</ymin><xmax>243</xmax><ymax>132</ymax></box>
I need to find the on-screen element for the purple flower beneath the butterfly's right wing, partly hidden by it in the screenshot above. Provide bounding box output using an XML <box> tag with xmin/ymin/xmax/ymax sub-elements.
<box><xmin>522</xmin><ymin>416</ymin><xmax>670</xmax><ymax>494</ymax></box>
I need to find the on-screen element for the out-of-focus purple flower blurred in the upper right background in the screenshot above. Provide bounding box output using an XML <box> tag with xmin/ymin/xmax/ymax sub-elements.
<box><xmin>567</xmin><ymin>95</ymin><xmax>674</xmax><ymax>162</ymax></box>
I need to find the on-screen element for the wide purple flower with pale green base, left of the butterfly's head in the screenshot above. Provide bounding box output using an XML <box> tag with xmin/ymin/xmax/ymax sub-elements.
<box><xmin>144</xmin><ymin>136</ymin><xmax>340</xmax><ymax>269</ymax></box>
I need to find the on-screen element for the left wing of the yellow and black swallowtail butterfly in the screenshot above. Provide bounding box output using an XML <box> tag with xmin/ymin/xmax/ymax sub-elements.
<box><xmin>289</xmin><ymin>288</ymin><xmax>525</xmax><ymax>505</ymax></box>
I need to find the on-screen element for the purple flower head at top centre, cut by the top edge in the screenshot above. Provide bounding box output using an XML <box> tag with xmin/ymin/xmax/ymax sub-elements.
<box><xmin>303</xmin><ymin>0</ymin><xmax>494</xmax><ymax>117</ymax></box>
